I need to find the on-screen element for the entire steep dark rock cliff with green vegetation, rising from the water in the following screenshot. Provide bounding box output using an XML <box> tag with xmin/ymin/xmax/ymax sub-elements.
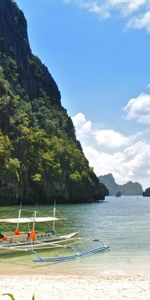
<box><xmin>0</xmin><ymin>0</ymin><xmax>107</xmax><ymax>204</ymax></box>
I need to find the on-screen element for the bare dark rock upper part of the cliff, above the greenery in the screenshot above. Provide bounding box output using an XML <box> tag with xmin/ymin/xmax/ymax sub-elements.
<box><xmin>0</xmin><ymin>0</ymin><xmax>61</xmax><ymax>105</ymax></box>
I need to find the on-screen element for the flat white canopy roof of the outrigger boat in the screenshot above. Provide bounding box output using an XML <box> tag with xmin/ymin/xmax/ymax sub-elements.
<box><xmin>0</xmin><ymin>217</ymin><xmax>65</xmax><ymax>224</ymax></box>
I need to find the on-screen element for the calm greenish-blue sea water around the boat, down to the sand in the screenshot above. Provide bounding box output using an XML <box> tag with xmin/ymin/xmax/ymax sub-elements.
<box><xmin>0</xmin><ymin>196</ymin><xmax>150</xmax><ymax>274</ymax></box>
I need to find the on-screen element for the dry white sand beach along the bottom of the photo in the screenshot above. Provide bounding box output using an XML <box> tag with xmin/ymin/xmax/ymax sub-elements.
<box><xmin>0</xmin><ymin>273</ymin><xmax>150</xmax><ymax>300</ymax></box>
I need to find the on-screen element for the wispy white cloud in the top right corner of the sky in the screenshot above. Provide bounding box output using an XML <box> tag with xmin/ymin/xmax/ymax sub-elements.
<box><xmin>63</xmin><ymin>0</ymin><xmax>150</xmax><ymax>32</ymax></box>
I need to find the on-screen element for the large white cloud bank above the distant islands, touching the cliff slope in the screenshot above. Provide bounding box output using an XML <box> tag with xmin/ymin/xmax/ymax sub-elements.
<box><xmin>73</xmin><ymin>114</ymin><xmax>150</xmax><ymax>188</ymax></box>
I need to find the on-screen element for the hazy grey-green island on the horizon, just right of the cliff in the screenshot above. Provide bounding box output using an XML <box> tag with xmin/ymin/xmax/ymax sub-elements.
<box><xmin>99</xmin><ymin>174</ymin><xmax>143</xmax><ymax>196</ymax></box>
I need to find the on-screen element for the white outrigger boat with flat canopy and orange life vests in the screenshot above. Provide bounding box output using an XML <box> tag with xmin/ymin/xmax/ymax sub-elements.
<box><xmin>0</xmin><ymin>207</ymin><xmax>79</xmax><ymax>255</ymax></box>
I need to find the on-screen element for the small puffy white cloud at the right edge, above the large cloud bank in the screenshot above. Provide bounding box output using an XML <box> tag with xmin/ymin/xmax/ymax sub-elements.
<box><xmin>124</xmin><ymin>94</ymin><xmax>150</xmax><ymax>124</ymax></box>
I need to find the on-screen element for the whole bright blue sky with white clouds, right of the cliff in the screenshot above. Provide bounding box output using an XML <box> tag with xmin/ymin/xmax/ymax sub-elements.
<box><xmin>16</xmin><ymin>0</ymin><xmax>150</xmax><ymax>189</ymax></box>
